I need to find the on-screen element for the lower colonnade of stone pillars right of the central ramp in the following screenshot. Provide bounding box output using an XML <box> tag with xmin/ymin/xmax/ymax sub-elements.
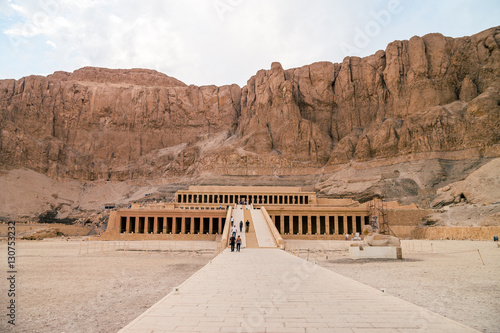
<box><xmin>269</xmin><ymin>212</ymin><xmax>370</xmax><ymax>235</ymax></box>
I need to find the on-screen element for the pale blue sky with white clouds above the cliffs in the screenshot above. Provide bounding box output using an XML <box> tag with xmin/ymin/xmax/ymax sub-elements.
<box><xmin>0</xmin><ymin>0</ymin><xmax>500</xmax><ymax>87</ymax></box>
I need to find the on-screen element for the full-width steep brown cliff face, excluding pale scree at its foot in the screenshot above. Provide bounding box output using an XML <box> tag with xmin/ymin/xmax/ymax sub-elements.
<box><xmin>0</xmin><ymin>27</ymin><xmax>500</xmax><ymax>197</ymax></box>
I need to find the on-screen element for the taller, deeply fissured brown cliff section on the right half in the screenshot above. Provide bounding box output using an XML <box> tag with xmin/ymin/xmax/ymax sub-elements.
<box><xmin>231</xmin><ymin>28</ymin><xmax>500</xmax><ymax>166</ymax></box>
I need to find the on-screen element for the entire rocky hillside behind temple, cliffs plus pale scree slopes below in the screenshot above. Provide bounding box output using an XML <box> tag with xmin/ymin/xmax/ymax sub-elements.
<box><xmin>0</xmin><ymin>27</ymin><xmax>500</xmax><ymax>224</ymax></box>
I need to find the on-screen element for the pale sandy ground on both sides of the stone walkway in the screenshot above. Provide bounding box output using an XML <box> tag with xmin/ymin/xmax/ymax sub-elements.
<box><xmin>0</xmin><ymin>239</ymin><xmax>500</xmax><ymax>332</ymax></box>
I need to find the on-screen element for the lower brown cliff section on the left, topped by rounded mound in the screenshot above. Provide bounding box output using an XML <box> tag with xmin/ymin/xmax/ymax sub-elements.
<box><xmin>0</xmin><ymin>68</ymin><xmax>241</xmax><ymax>180</ymax></box>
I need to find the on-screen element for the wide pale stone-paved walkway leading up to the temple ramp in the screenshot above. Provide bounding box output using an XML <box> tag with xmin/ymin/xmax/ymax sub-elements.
<box><xmin>120</xmin><ymin>249</ymin><xmax>477</xmax><ymax>333</ymax></box>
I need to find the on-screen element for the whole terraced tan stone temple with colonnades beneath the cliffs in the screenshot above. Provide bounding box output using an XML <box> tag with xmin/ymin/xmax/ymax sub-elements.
<box><xmin>104</xmin><ymin>186</ymin><xmax>376</xmax><ymax>240</ymax></box>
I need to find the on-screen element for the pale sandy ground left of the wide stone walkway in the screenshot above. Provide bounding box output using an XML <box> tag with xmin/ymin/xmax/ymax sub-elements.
<box><xmin>0</xmin><ymin>239</ymin><xmax>219</xmax><ymax>332</ymax></box>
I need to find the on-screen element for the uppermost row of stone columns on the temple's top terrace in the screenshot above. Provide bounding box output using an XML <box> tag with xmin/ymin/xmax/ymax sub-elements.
<box><xmin>177</xmin><ymin>193</ymin><xmax>309</xmax><ymax>205</ymax></box>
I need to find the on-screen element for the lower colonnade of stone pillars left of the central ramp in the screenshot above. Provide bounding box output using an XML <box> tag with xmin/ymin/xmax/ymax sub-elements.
<box><xmin>119</xmin><ymin>216</ymin><xmax>225</xmax><ymax>234</ymax></box>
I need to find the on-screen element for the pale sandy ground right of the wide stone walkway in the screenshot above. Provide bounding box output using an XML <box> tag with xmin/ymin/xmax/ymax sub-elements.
<box><xmin>286</xmin><ymin>240</ymin><xmax>500</xmax><ymax>332</ymax></box>
